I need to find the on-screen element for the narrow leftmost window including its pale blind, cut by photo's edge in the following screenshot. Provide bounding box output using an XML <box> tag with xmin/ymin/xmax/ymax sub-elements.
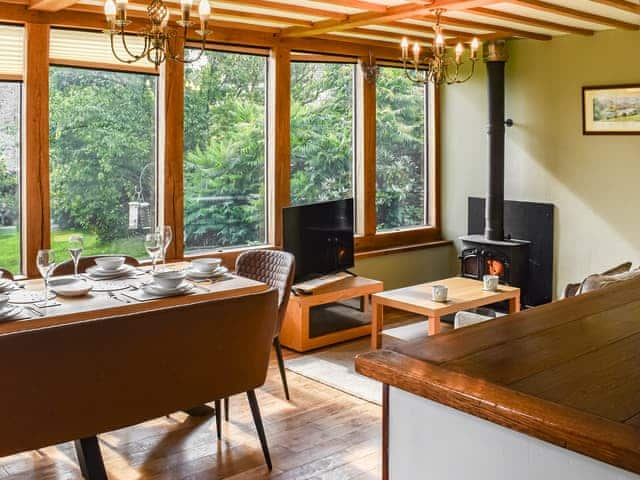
<box><xmin>0</xmin><ymin>25</ymin><xmax>24</xmax><ymax>273</ymax></box>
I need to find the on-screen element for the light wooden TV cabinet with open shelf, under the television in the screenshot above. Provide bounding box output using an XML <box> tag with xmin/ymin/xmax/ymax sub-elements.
<box><xmin>280</xmin><ymin>277</ymin><xmax>384</xmax><ymax>352</ymax></box>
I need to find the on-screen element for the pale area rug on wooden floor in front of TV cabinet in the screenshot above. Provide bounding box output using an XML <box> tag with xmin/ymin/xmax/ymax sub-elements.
<box><xmin>286</xmin><ymin>337</ymin><xmax>382</xmax><ymax>405</ymax></box>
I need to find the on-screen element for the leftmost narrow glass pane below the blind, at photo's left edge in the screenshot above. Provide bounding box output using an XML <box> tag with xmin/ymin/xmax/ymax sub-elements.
<box><xmin>0</xmin><ymin>82</ymin><xmax>22</xmax><ymax>273</ymax></box>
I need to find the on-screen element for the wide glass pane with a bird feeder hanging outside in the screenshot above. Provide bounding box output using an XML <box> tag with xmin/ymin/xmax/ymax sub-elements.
<box><xmin>49</xmin><ymin>66</ymin><xmax>157</xmax><ymax>262</ymax></box>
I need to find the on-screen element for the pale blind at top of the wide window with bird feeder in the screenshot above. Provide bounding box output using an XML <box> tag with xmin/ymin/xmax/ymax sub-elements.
<box><xmin>49</xmin><ymin>29</ymin><xmax>158</xmax><ymax>74</ymax></box>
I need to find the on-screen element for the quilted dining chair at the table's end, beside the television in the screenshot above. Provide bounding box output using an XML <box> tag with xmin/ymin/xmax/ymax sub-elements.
<box><xmin>225</xmin><ymin>250</ymin><xmax>296</xmax><ymax>414</ymax></box>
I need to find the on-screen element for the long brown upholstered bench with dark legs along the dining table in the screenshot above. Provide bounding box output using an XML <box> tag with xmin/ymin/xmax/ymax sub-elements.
<box><xmin>0</xmin><ymin>289</ymin><xmax>278</xmax><ymax>472</ymax></box>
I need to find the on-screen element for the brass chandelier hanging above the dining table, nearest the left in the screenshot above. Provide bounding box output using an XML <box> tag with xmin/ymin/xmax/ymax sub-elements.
<box><xmin>104</xmin><ymin>0</ymin><xmax>211</xmax><ymax>68</ymax></box>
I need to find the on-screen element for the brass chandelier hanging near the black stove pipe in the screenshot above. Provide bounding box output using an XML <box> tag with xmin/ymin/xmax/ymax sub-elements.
<box><xmin>401</xmin><ymin>9</ymin><xmax>480</xmax><ymax>85</ymax></box>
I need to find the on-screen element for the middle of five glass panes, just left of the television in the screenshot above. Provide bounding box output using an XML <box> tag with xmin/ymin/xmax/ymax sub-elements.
<box><xmin>184</xmin><ymin>51</ymin><xmax>267</xmax><ymax>253</ymax></box>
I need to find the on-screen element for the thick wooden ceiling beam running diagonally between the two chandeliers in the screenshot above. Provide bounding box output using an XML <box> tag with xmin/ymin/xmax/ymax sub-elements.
<box><xmin>282</xmin><ymin>0</ymin><xmax>503</xmax><ymax>38</ymax></box>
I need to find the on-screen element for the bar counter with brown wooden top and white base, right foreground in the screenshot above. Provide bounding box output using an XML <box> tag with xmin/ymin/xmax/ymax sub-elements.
<box><xmin>356</xmin><ymin>280</ymin><xmax>640</xmax><ymax>480</ymax></box>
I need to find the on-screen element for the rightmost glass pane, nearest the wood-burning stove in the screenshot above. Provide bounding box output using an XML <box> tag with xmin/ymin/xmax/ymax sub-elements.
<box><xmin>376</xmin><ymin>67</ymin><xmax>427</xmax><ymax>231</ymax></box>
